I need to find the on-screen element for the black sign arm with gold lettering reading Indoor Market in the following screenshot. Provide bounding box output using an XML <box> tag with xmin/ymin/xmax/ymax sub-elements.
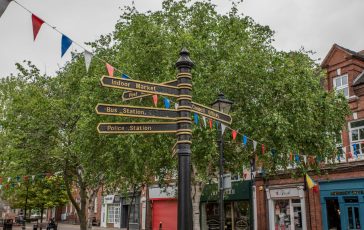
<box><xmin>101</xmin><ymin>76</ymin><xmax>178</xmax><ymax>97</ymax></box>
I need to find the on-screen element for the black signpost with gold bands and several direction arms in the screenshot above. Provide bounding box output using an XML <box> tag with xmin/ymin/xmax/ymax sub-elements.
<box><xmin>95</xmin><ymin>48</ymin><xmax>232</xmax><ymax>230</ymax></box>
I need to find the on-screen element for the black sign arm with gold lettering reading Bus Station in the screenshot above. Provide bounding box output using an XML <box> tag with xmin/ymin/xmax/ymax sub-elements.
<box><xmin>95</xmin><ymin>104</ymin><xmax>177</xmax><ymax>120</ymax></box>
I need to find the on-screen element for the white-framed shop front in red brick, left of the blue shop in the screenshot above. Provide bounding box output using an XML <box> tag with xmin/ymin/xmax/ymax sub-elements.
<box><xmin>266</xmin><ymin>184</ymin><xmax>307</xmax><ymax>230</ymax></box>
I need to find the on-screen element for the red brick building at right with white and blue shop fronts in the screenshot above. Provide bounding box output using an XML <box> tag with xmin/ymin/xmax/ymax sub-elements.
<box><xmin>253</xmin><ymin>44</ymin><xmax>364</xmax><ymax>230</ymax></box>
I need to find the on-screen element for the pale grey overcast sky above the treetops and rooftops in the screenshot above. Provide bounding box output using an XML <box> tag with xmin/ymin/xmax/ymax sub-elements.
<box><xmin>0</xmin><ymin>0</ymin><xmax>364</xmax><ymax>77</ymax></box>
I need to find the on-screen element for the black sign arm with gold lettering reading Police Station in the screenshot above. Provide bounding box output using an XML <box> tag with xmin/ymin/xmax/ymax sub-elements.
<box><xmin>97</xmin><ymin>122</ymin><xmax>177</xmax><ymax>134</ymax></box>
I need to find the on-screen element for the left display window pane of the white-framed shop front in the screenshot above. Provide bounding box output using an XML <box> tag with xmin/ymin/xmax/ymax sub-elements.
<box><xmin>274</xmin><ymin>200</ymin><xmax>291</xmax><ymax>230</ymax></box>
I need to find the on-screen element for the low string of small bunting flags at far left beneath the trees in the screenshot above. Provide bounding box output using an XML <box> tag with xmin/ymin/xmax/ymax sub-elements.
<box><xmin>0</xmin><ymin>173</ymin><xmax>54</xmax><ymax>190</ymax></box>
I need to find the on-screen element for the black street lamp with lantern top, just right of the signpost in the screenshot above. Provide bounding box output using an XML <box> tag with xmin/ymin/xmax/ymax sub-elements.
<box><xmin>211</xmin><ymin>93</ymin><xmax>233</xmax><ymax>230</ymax></box>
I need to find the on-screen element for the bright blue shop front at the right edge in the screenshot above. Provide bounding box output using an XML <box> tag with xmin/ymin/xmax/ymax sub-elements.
<box><xmin>319</xmin><ymin>179</ymin><xmax>364</xmax><ymax>230</ymax></box>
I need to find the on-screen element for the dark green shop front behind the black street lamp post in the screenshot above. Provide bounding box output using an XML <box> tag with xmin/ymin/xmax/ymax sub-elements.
<box><xmin>200</xmin><ymin>181</ymin><xmax>253</xmax><ymax>230</ymax></box>
